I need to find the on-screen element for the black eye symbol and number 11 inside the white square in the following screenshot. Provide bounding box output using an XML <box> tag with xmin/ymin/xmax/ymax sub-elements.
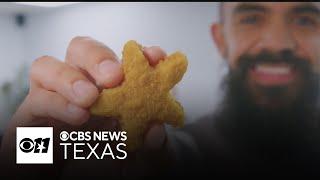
<box><xmin>19</xmin><ymin>138</ymin><xmax>50</xmax><ymax>153</ymax></box>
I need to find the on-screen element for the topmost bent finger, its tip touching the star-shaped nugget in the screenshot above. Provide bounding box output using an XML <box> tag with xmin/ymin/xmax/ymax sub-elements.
<box><xmin>66</xmin><ymin>37</ymin><xmax>123</xmax><ymax>88</ymax></box>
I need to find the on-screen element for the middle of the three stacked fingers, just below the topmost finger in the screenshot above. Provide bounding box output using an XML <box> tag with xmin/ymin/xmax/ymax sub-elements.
<box><xmin>30</xmin><ymin>56</ymin><xmax>99</xmax><ymax>108</ymax></box>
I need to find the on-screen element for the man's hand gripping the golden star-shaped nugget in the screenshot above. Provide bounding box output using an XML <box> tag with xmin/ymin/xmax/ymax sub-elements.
<box><xmin>1</xmin><ymin>37</ymin><xmax>166</xmax><ymax>158</ymax></box>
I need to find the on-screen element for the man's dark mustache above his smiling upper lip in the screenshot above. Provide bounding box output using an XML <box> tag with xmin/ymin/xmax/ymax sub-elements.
<box><xmin>236</xmin><ymin>50</ymin><xmax>312</xmax><ymax>74</ymax></box>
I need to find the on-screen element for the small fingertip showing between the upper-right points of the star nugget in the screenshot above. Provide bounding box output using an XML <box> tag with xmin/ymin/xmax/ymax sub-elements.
<box><xmin>143</xmin><ymin>46</ymin><xmax>167</xmax><ymax>66</ymax></box>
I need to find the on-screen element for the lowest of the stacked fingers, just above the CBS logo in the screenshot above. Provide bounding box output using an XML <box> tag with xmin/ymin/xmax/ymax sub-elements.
<box><xmin>24</xmin><ymin>88</ymin><xmax>89</xmax><ymax>125</ymax></box>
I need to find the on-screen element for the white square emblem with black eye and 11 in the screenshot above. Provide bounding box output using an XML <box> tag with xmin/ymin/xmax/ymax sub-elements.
<box><xmin>16</xmin><ymin>127</ymin><xmax>53</xmax><ymax>164</ymax></box>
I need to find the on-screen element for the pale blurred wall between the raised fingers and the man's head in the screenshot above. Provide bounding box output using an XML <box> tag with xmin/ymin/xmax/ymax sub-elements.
<box><xmin>25</xmin><ymin>3</ymin><xmax>223</xmax><ymax>124</ymax></box>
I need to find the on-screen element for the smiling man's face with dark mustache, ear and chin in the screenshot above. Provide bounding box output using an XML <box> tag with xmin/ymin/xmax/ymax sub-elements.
<box><xmin>212</xmin><ymin>2</ymin><xmax>320</xmax><ymax>107</ymax></box>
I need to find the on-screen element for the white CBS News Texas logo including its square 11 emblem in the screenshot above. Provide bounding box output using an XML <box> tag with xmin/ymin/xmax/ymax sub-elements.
<box><xmin>16</xmin><ymin>127</ymin><xmax>127</xmax><ymax>164</ymax></box>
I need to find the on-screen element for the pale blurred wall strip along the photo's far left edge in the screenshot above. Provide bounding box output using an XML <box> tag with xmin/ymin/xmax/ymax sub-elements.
<box><xmin>0</xmin><ymin>14</ymin><xmax>27</xmax><ymax>132</ymax></box>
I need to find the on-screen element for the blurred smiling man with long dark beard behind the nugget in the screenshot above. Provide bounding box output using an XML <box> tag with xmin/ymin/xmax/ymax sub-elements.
<box><xmin>170</xmin><ymin>2</ymin><xmax>320</xmax><ymax>174</ymax></box>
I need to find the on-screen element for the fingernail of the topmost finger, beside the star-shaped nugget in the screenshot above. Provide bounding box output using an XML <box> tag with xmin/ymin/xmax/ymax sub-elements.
<box><xmin>98</xmin><ymin>60</ymin><xmax>121</xmax><ymax>85</ymax></box>
